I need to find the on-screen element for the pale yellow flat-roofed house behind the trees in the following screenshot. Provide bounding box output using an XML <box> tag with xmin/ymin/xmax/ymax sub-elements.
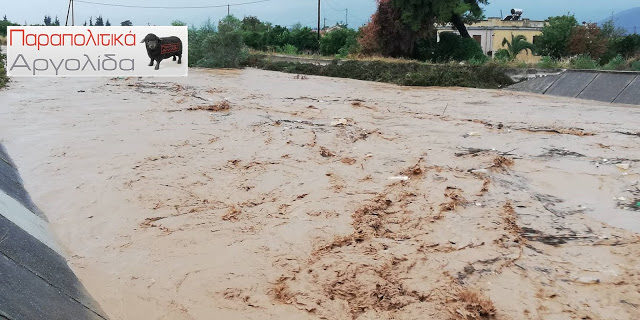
<box><xmin>438</xmin><ymin>9</ymin><xmax>546</xmax><ymax>63</ymax></box>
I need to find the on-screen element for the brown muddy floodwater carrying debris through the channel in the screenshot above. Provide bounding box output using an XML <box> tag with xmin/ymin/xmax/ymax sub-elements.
<box><xmin>0</xmin><ymin>69</ymin><xmax>640</xmax><ymax>320</ymax></box>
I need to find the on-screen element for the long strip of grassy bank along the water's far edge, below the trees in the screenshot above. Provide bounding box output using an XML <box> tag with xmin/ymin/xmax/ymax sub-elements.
<box><xmin>246</xmin><ymin>54</ymin><xmax>513</xmax><ymax>89</ymax></box>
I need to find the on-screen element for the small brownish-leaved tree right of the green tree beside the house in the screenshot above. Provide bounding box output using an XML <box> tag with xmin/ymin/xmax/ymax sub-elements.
<box><xmin>568</xmin><ymin>23</ymin><xmax>607</xmax><ymax>59</ymax></box>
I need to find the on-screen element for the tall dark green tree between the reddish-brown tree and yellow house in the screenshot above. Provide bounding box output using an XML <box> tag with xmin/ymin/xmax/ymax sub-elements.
<box><xmin>393</xmin><ymin>0</ymin><xmax>488</xmax><ymax>38</ymax></box>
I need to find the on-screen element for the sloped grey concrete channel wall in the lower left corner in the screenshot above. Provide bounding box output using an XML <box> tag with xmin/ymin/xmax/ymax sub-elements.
<box><xmin>0</xmin><ymin>145</ymin><xmax>106</xmax><ymax>320</ymax></box>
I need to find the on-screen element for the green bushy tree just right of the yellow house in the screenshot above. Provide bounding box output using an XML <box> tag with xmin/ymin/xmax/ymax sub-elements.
<box><xmin>536</xmin><ymin>15</ymin><xmax>578</xmax><ymax>59</ymax></box>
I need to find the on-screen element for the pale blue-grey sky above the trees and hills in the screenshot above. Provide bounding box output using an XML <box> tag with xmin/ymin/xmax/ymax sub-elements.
<box><xmin>0</xmin><ymin>0</ymin><xmax>640</xmax><ymax>26</ymax></box>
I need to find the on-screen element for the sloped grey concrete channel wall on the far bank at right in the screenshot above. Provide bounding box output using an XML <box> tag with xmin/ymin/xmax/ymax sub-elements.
<box><xmin>507</xmin><ymin>70</ymin><xmax>640</xmax><ymax>105</ymax></box>
